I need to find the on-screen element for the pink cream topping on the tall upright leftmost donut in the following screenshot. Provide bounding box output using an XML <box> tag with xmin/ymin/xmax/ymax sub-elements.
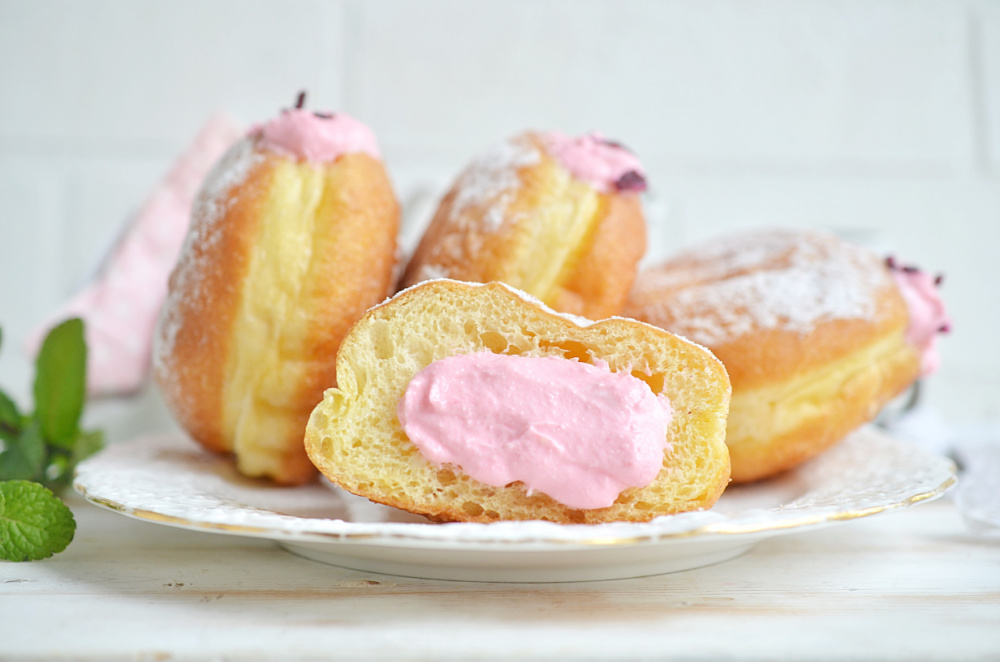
<box><xmin>250</xmin><ymin>108</ymin><xmax>381</xmax><ymax>163</ymax></box>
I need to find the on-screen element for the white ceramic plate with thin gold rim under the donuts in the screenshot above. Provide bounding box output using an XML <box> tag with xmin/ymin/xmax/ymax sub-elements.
<box><xmin>74</xmin><ymin>428</ymin><xmax>955</xmax><ymax>582</ymax></box>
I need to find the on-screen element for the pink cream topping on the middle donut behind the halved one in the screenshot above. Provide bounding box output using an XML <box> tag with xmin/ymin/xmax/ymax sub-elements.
<box><xmin>540</xmin><ymin>131</ymin><xmax>646</xmax><ymax>193</ymax></box>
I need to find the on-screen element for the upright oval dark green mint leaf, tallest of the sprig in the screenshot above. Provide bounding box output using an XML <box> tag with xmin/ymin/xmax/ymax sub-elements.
<box><xmin>35</xmin><ymin>318</ymin><xmax>87</xmax><ymax>450</ymax></box>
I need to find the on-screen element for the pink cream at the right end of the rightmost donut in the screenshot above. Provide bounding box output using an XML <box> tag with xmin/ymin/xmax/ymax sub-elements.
<box><xmin>892</xmin><ymin>269</ymin><xmax>951</xmax><ymax>377</ymax></box>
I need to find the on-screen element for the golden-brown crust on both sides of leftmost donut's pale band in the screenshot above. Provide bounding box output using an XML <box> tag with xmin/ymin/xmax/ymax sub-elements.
<box><xmin>156</xmin><ymin>151</ymin><xmax>399</xmax><ymax>484</ymax></box>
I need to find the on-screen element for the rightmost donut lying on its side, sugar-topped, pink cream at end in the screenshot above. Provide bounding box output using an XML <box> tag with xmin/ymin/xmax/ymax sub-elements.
<box><xmin>625</xmin><ymin>230</ymin><xmax>949</xmax><ymax>482</ymax></box>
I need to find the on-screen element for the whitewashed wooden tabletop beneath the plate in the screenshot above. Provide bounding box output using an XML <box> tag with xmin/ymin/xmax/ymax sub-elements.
<box><xmin>0</xmin><ymin>495</ymin><xmax>1000</xmax><ymax>660</ymax></box>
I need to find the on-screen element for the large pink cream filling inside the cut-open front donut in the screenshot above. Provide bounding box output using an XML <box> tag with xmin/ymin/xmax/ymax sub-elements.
<box><xmin>397</xmin><ymin>352</ymin><xmax>673</xmax><ymax>509</ymax></box>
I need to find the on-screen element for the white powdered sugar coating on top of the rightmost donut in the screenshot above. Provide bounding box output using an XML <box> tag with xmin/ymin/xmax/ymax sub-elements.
<box><xmin>639</xmin><ymin>231</ymin><xmax>891</xmax><ymax>346</ymax></box>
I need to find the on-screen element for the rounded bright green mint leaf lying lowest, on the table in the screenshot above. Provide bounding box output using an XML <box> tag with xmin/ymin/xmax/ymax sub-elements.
<box><xmin>0</xmin><ymin>480</ymin><xmax>76</xmax><ymax>561</ymax></box>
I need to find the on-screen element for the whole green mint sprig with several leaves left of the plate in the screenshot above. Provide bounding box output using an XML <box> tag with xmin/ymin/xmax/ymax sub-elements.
<box><xmin>0</xmin><ymin>319</ymin><xmax>104</xmax><ymax>561</ymax></box>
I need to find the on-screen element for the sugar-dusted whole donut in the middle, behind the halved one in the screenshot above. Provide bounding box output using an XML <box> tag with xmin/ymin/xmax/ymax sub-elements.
<box><xmin>400</xmin><ymin>132</ymin><xmax>646</xmax><ymax>319</ymax></box>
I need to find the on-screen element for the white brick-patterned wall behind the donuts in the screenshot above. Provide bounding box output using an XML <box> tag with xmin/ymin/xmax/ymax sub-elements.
<box><xmin>0</xmin><ymin>0</ymin><xmax>1000</xmax><ymax>434</ymax></box>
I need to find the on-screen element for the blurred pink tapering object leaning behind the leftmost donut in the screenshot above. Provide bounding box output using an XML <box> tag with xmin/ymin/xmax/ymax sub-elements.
<box><xmin>26</xmin><ymin>114</ymin><xmax>244</xmax><ymax>397</ymax></box>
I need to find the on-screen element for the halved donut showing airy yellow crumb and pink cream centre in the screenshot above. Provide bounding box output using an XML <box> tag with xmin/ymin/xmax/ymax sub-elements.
<box><xmin>305</xmin><ymin>279</ymin><xmax>730</xmax><ymax>524</ymax></box>
